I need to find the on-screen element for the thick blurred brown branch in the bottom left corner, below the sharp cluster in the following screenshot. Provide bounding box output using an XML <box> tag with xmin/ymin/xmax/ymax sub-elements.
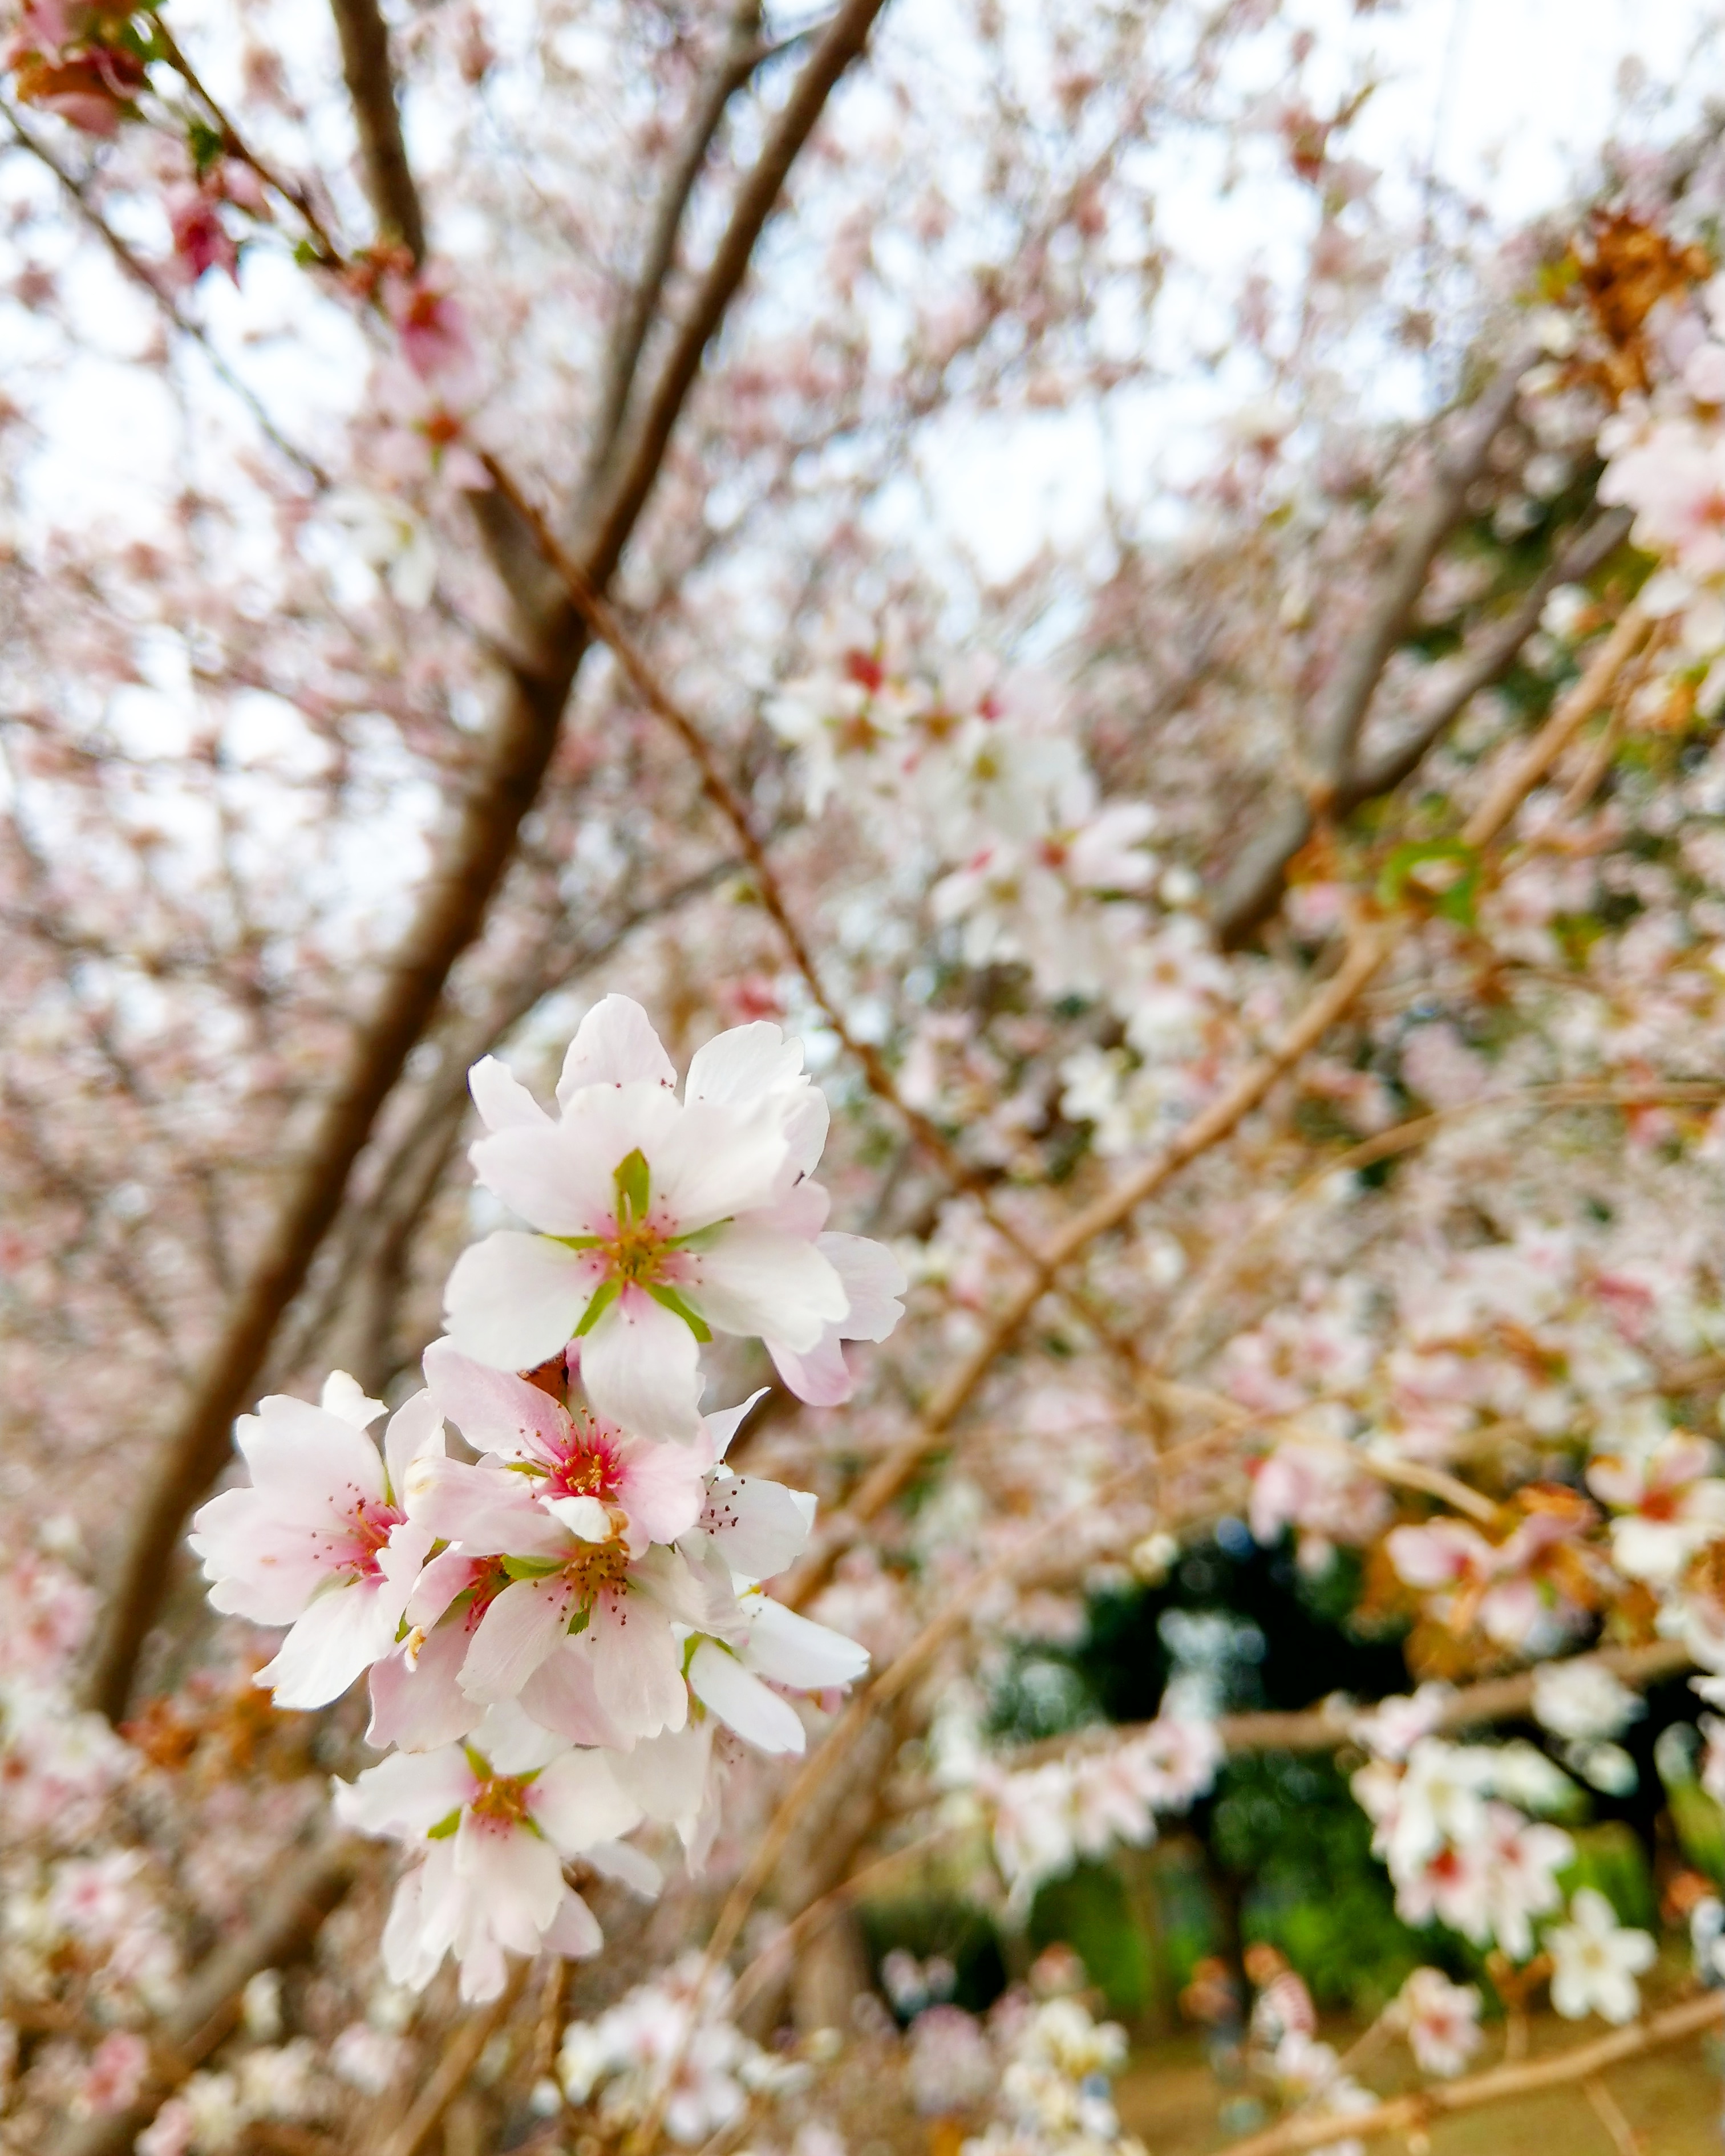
<box><xmin>52</xmin><ymin>1839</ymin><xmax>367</xmax><ymax>2156</ymax></box>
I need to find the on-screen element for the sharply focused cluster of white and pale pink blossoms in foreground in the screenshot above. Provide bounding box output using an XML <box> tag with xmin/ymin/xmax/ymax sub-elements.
<box><xmin>192</xmin><ymin>996</ymin><xmax>904</xmax><ymax>1999</ymax></box>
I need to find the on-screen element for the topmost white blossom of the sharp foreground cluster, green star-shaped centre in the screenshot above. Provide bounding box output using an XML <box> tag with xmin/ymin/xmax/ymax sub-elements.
<box><xmin>448</xmin><ymin>996</ymin><xmax>882</xmax><ymax>1442</ymax></box>
